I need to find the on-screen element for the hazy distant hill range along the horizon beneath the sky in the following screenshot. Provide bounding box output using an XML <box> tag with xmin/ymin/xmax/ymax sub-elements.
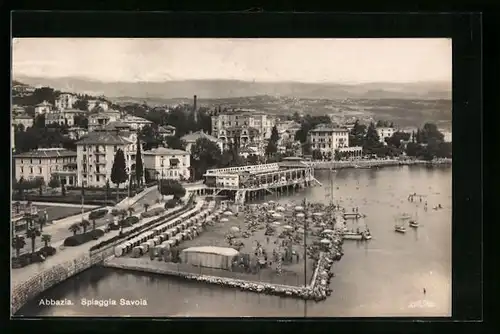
<box><xmin>15</xmin><ymin>76</ymin><xmax>451</xmax><ymax>100</ymax></box>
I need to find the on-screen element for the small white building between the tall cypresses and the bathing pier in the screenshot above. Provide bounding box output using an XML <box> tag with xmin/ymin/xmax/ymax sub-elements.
<box><xmin>146</xmin><ymin>147</ymin><xmax>191</xmax><ymax>180</ymax></box>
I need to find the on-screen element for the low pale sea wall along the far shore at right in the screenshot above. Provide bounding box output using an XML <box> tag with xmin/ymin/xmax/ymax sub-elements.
<box><xmin>310</xmin><ymin>159</ymin><xmax>452</xmax><ymax>170</ymax></box>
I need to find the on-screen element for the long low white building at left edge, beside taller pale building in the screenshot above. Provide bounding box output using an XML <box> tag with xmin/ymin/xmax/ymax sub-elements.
<box><xmin>13</xmin><ymin>148</ymin><xmax>77</xmax><ymax>184</ymax></box>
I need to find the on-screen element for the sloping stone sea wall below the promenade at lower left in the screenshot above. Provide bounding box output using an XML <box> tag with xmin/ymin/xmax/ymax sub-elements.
<box><xmin>11</xmin><ymin>248</ymin><xmax>113</xmax><ymax>314</ymax></box>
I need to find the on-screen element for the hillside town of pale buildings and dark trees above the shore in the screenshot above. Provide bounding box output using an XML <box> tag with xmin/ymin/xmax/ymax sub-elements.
<box><xmin>11</xmin><ymin>84</ymin><xmax>451</xmax><ymax>194</ymax></box>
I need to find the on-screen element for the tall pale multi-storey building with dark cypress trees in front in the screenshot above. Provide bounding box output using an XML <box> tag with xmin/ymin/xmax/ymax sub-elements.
<box><xmin>76</xmin><ymin>130</ymin><xmax>144</xmax><ymax>187</ymax></box>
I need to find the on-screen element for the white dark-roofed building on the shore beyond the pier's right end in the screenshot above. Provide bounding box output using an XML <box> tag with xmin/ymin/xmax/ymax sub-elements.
<box><xmin>309</xmin><ymin>124</ymin><xmax>349</xmax><ymax>156</ymax></box>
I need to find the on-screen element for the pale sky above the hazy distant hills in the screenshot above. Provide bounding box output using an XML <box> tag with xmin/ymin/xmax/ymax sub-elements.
<box><xmin>12</xmin><ymin>38</ymin><xmax>452</xmax><ymax>83</ymax></box>
